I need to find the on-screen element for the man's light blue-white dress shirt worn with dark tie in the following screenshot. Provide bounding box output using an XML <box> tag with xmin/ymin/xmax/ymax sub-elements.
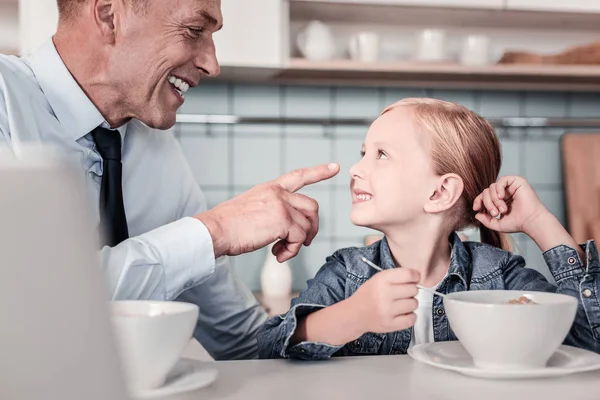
<box><xmin>0</xmin><ymin>40</ymin><xmax>267</xmax><ymax>358</ymax></box>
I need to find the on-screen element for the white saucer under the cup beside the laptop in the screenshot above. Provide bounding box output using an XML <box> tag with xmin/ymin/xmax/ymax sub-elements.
<box><xmin>131</xmin><ymin>358</ymin><xmax>217</xmax><ymax>400</ymax></box>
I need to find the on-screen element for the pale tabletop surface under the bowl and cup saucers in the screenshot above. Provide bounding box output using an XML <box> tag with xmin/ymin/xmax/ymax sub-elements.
<box><xmin>174</xmin><ymin>356</ymin><xmax>600</xmax><ymax>400</ymax></box>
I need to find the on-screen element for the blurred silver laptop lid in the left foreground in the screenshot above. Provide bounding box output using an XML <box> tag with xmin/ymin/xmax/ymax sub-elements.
<box><xmin>0</xmin><ymin>149</ymin><xmax>127</xmax><ymax>400</ymax></box>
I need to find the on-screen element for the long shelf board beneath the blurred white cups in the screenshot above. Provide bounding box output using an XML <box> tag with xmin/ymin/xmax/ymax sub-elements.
<box><xmin>219</xmin><ymin>58</ymin><xmax>600</xmax><ymax>91</ymax></box>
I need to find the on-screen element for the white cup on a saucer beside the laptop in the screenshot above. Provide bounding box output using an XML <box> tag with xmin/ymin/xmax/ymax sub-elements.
<box><xmin>111</xmin><ymin>300</ymin><xmax>199</xmax><ymax>393</ymax></box>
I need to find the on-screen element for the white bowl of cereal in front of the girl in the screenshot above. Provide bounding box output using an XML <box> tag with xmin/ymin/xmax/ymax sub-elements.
<box><xmin>444</xmin><ymin>290</ymin><xmax>577</xmax><ymax>370</ymax></box>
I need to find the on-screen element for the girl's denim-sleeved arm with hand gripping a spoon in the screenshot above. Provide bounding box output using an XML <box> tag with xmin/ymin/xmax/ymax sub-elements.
<box><xmin>258</xmin><ymin>254</ymin><xmax>419</xmax><ymax>360</ymax></box>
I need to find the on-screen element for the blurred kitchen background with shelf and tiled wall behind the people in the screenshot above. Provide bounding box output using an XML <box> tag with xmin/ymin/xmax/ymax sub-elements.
<box><xmin>0</xmin><ymin>0</ymin><xmax>600</xmax><ymax>292</ymax></box>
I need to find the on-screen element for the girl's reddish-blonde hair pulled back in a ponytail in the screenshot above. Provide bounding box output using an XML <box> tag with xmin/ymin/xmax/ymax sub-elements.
<box><xmin>381</xmin><ymin>98</ymin><xmax>511</xmax><ymax>250</ymax></box>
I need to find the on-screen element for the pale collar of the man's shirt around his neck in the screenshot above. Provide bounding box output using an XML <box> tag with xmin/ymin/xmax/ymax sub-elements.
<box><xmin>27</xmin><ymin>38</ymin><xmax>127</xmax><ymax>140</ymax></box>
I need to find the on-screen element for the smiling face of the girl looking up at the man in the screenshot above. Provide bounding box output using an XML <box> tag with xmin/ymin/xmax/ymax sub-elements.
<box><xmin>350</xmin><ymin>107</ymin><xmax>439</xmax><ymax>233</ymax></box>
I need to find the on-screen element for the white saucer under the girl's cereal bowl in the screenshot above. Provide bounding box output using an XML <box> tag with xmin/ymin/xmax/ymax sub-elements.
<box><xmin>408</xmin><ymin>341</ymin><xmax>600</xmax><ymax>379</ymax></box>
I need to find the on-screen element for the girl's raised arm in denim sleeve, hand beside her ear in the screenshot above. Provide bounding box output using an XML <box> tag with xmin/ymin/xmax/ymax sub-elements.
<box><xmin>473</xmin><ymin>176</ymin><xmax>600</xmax><ymax>352</ymax></box>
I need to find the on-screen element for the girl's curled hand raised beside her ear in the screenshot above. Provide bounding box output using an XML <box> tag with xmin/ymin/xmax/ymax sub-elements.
<box><xmin>473</xmin><ymin>176</ymin><xmax>548</xmax><ymax>234</ymax></box>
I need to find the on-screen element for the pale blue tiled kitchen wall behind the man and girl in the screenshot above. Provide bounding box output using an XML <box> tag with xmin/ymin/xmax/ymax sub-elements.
<box><xmin>175</xmin><ymin>82</ymin><xmax>600</xmax><ymax>290</ymax></box>
